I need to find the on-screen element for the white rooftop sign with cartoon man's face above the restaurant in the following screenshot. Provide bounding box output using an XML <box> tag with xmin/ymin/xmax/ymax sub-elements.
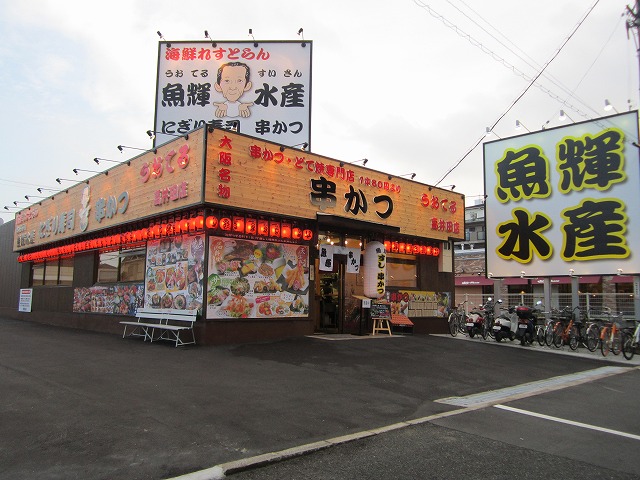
<box><xmin>155</xmin><ymin>41</ymin><xmax>312</xmax><ymax>146</ymax></box>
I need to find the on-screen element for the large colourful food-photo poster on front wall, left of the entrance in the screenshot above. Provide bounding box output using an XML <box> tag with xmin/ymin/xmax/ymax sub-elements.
<box><xmin>207</xmin><ymin>237</ymin><xmax>309</xmax><ymax>319</ymax></box>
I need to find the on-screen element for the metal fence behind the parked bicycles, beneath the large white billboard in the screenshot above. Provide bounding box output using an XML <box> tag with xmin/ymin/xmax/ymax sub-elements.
<box><xmin>456</xmin><ymin>293</ymin><xmax>636</xmax><ymax>320</ymax></box>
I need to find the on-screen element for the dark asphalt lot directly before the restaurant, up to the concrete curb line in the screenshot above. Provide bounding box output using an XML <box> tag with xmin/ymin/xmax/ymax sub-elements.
<box><xmin>0</xmin><ymin>319</ymin><xmax>631</xmax><ymax>479</ymax></box>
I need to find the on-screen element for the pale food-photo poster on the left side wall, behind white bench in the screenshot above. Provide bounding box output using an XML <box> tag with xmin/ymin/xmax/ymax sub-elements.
<box><xmin>144</xmin><ymin>235</ymin><xmax>204</xmax><ymax>310</ymax></box>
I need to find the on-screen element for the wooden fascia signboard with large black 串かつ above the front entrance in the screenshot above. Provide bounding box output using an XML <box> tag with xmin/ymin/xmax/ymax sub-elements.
<box><xmin>204</xmin><ymin>130</ymin><xmax>464</xmax><ymax>240</ymax></box>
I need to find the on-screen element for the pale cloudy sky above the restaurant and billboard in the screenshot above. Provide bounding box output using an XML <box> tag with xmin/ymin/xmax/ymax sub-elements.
<box><xmin>0</xmin><ymin>0</ymin><xmax>639</xmax><ymax>226</ymax></box>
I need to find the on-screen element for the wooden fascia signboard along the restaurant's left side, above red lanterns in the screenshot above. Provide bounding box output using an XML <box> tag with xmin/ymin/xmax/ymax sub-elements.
<box><xmin>14</xmin><ymin>129</ymin><xmax>204</xmax><ymax>251</ymax></box>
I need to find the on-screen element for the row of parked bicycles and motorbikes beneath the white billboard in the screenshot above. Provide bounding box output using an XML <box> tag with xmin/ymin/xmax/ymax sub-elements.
<box><xmin>449</xmin><ymin>297</ymin><xmax>640</xmax><ymax>360</ymax></box>
